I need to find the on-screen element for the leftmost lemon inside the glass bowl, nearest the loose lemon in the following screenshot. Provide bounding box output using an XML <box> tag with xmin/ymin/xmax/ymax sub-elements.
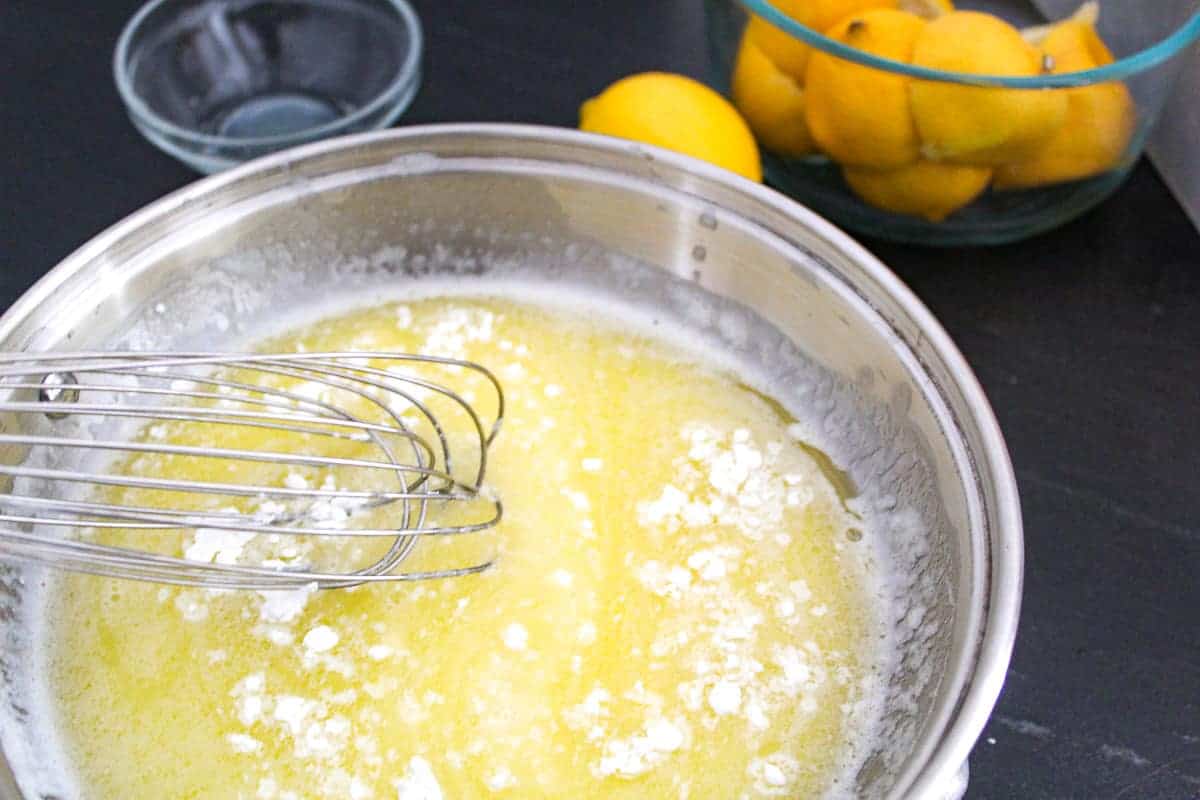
<box><xmin>731</xmin><ymin>35</ymin><xmax>814</xmax><ymax>158</ymax></box>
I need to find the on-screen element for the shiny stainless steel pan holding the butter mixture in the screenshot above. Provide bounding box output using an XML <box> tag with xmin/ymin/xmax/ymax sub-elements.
<box><xmin>0</xmin><ymin>125</ymin><xmax>1022</xmax><ymax>799</ymax></box>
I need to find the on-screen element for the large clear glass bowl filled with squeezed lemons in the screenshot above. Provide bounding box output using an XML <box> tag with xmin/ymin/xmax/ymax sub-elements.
<box><xmin>707</xmin><ymin>0</ymin><xmax>1200</xmax><ymax>245</ymax></box>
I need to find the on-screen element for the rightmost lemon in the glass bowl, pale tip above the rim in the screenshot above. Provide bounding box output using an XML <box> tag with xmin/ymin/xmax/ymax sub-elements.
<box><xmin>996</xmin><ymin>4</ymin><xmax>1136</xmax><ymax>188</ymax></box>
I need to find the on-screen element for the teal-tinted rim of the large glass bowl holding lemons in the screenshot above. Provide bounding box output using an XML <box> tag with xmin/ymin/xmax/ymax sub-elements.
<box><xmin>731</xmin><ymin>0</ymin><xmax>1200</xmax><ymax>89</ymax></box>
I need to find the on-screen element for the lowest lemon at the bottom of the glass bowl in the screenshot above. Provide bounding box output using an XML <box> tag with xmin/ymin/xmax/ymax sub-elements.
<box><xmin>842</xmin><ymin>160</ymin><xmax>991</xmax><ymax>222</ymax></box>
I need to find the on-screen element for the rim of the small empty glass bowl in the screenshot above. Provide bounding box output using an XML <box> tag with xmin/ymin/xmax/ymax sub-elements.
<box><xmin>113</xmin><ymin>0</ymin><xmax>424</xmax><ymax>149</ymax></box>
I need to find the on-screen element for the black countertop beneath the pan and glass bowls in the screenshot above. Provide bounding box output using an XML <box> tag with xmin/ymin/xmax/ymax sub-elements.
<box><xmin>0</xmin><ymin>0</ymin><xmax>1200</xmax><ymax>800</ymax></box>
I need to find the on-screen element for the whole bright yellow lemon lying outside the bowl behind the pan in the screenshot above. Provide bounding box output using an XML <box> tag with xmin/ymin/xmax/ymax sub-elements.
<box><xmin>580</xmin><ymin>72</ymin><xmax>762</xmax><ymax>181</ymax></box>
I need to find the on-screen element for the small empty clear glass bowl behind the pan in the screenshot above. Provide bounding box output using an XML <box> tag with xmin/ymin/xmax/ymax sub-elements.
<box><xmin>114</xmin><ymin>0</ymin><xmax>421</xmax><ymax>173</ymax></box>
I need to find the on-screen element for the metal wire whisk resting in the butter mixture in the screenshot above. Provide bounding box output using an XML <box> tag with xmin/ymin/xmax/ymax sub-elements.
<box><xmin>0</xmin><ymin>351</ymin><xmax>504</xmax><ymax>590</ymax></box>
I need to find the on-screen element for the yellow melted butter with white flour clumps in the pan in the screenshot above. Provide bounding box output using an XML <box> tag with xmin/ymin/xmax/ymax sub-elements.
<box><xmin>49</xmin><ymin>299</ymin><xmax>875</xmax><ymax>800</ymax></box>
